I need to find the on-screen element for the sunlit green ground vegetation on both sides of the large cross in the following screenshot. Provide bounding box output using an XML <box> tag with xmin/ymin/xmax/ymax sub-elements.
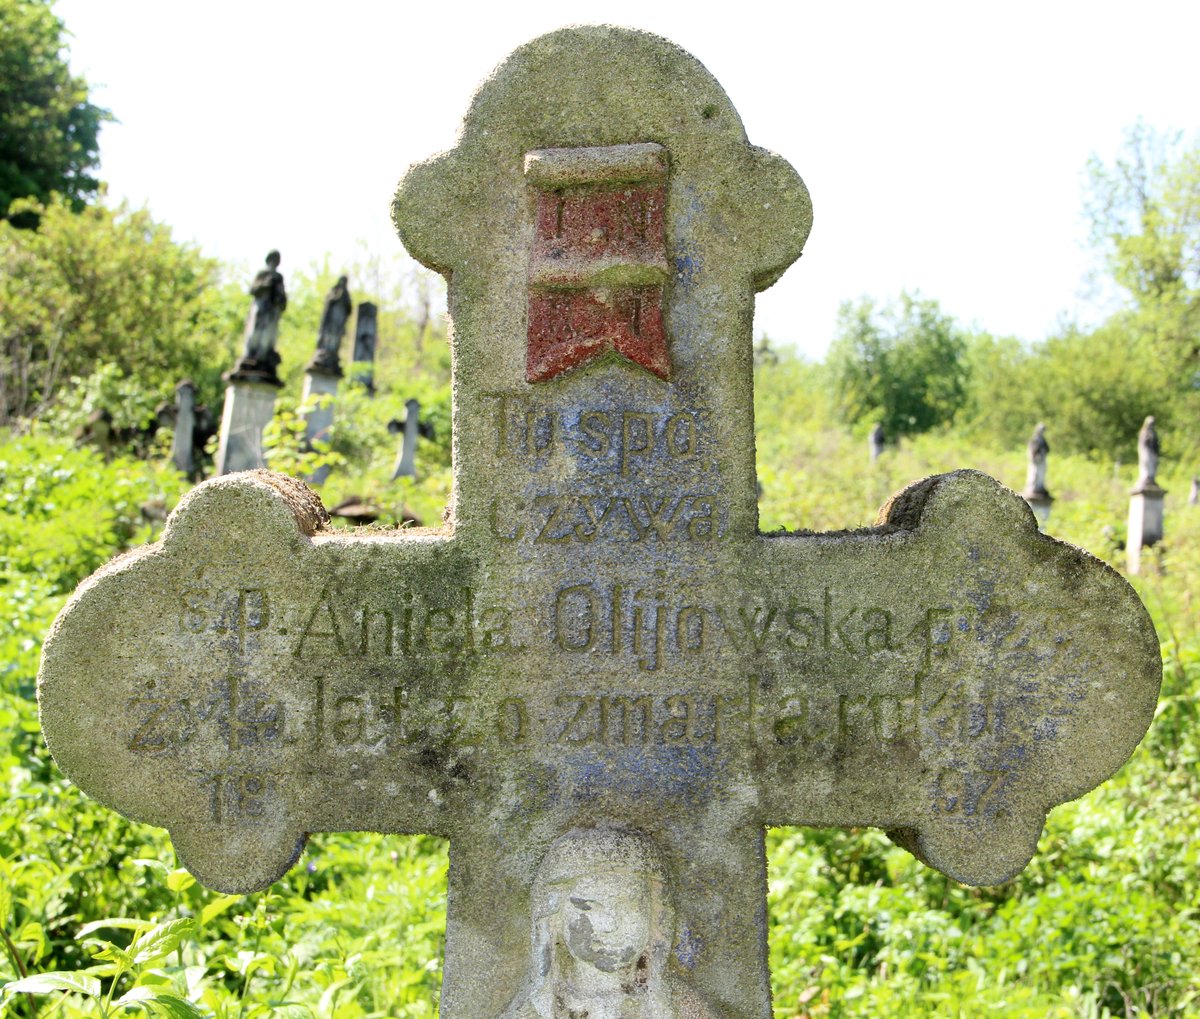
<box><xmin>0</xmin><ymin>393</ymin><xmax>1200</xmax><ymax>1019</ymax></box>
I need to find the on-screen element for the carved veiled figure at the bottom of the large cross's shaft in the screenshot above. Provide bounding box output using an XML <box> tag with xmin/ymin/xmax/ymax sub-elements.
<box><xmin>503</xmin><ymin>828</ymin><xmax>718</xmax><ymax>1019</ymax></box>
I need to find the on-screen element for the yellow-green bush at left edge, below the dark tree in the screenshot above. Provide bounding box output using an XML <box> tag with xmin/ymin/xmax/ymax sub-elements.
<box><xmin>0</xmin><ymin>198</ymin><xmax>245</xmax><ymax>426</ymax></box>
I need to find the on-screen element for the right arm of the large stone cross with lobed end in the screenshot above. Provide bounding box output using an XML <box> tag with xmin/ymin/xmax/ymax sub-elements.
<box><xmin>744</xmin><ymin>470</ymin><xmax>1162</xmax><ymax>885</ymax></box>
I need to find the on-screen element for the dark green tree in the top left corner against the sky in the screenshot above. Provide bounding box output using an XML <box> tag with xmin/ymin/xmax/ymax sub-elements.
<box><xmin>0</xmin><ymin>0</ymin><xmax>110</xmax><ymax>217</ymax></box>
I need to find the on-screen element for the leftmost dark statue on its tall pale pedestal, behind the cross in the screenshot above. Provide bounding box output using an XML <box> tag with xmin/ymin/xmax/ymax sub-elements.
<box><xmin>216</xmin><ymin>251</ymin><xmax>288</xmax><ymax>474</ymax></box>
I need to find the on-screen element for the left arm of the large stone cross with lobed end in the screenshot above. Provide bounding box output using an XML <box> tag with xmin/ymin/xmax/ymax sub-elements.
<box><xmin>38</xmin><ymin>472</ymin><xmax>475</xmax><ymax>892</ymax></box>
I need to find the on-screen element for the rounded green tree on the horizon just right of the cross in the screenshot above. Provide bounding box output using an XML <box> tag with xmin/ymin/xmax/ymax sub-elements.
<box><xmin>828</xmin><ymin>293</ymin><xmax>967</xmax><ymax>436</ymax></box>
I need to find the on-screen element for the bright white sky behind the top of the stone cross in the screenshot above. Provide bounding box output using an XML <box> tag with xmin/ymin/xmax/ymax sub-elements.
<box><xmin>55</xmin><ymin>0</ymin><xmax>1200</xmax><ymax>356</ymax></box>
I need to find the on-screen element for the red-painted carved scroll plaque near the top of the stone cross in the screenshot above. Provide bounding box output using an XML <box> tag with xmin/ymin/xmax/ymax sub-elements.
<box><xmin>526</xmin><ymin>143</ymin><xmax>671</xmax><ymax>382</ymax></box>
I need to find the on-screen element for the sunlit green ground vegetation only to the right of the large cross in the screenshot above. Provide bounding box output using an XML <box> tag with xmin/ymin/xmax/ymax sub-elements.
<box><xmin>756</xmin><ymin>420</ymin><xmax>1200</xmax><ymax>1019</ymax></box>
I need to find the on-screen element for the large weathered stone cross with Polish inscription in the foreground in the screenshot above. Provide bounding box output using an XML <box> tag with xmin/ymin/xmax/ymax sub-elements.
<box><xmin>38</xmin><ymin>28</ymin><xmax>1160</xmax><ymax>1019</ymax></box>
